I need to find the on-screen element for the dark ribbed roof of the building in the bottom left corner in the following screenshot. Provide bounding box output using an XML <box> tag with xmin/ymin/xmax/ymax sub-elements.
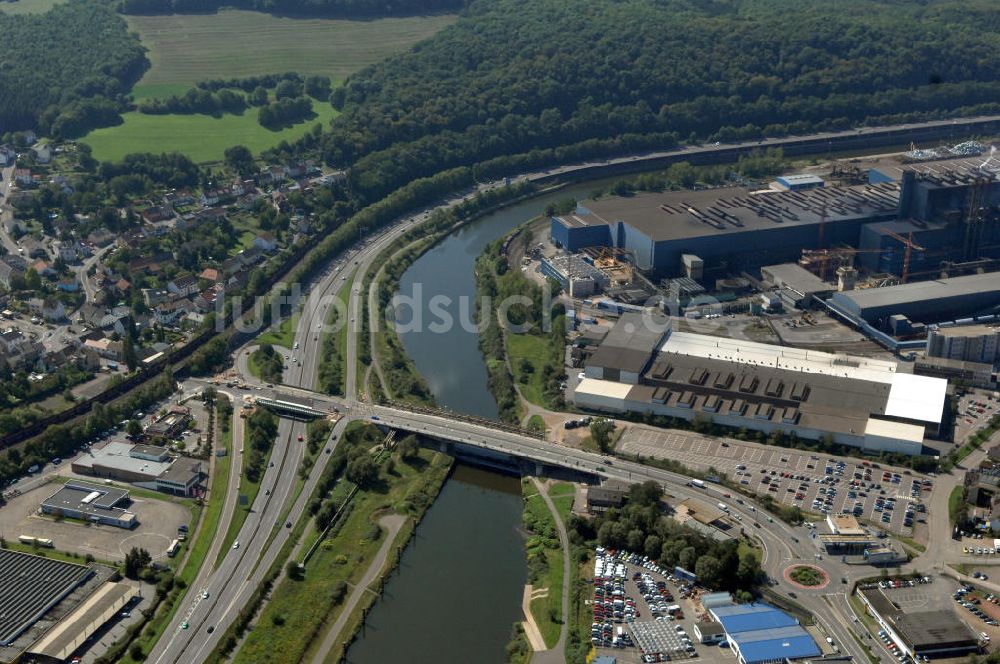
<box><xmin>0</xmin><ymin>549</ymin><xmax>93</xmax><ymax>646</ymax></box>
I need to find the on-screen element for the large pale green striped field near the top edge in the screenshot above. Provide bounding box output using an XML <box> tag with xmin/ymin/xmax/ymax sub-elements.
<box><xmin>123</xmin><ymin>9</ymin><xmax>455</xmax><ymax>98</ymax></box>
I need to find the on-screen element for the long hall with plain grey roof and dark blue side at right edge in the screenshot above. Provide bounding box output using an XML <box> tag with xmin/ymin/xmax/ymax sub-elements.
<box><xmin>830</xmin><ymin>273</ymin><xmax>1000</xmax><ymax>326</ymax></box>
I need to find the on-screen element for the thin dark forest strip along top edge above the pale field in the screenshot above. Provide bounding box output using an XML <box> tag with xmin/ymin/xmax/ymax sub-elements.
<box><xmin>120</xmin><ymin>0</ymin><xmax>464</xmax><ymax>18</ymax></box>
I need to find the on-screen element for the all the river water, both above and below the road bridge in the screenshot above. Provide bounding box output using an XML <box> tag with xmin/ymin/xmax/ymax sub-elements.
<box><xmin>347</xmin><ymin>181</ymin><xmax>606</xmax><ymax>664</ymax></box>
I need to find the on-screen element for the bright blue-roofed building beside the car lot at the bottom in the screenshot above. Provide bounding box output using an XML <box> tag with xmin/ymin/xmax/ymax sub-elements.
<box><xmin>708</xmin><ymin>603</ymin><xmax>821</xmax><ymax>664</ymax></box>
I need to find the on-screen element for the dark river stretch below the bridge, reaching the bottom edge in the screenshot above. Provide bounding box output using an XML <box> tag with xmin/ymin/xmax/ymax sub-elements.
<box><xmin>347</xmin><ymin>465</ymin><xmax>527</xmax><ymax>664</ymax></box>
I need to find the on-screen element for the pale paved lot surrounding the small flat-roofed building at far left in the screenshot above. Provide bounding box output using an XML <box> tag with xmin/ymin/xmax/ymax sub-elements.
<box><xmin>0</xmin><ymin>482</ymin><xmax>191</xmax><ymax>562</ymax></box>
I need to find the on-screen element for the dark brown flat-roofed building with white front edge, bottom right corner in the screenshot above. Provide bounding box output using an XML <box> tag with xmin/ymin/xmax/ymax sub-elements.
<box><xmin>858</xmin><ymin>586</ymin><xmax>979</xmax><ymax>660</ymax></box>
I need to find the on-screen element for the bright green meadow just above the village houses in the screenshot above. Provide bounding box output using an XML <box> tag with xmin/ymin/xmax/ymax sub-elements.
<box><xmin>81</xmin><ymin>103</ymin><xmax>337</xmax><ymax>163</ymax></box>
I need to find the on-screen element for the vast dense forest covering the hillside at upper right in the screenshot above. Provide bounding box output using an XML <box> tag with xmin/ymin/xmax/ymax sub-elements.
<box><xmin>276</xmin><ymin>0</ymin><xmax>1000</xmax><ymax>201</ymax></box>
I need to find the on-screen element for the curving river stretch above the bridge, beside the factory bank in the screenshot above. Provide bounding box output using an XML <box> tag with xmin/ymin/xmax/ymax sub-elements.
<box><xmin>399</xmin><ymin>180</ymin><xmax>611</xmax><ymax>419</ymax></box>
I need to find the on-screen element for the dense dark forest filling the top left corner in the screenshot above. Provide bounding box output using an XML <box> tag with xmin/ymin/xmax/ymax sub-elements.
<box><xmin>0</xmin><ymin>0</ymin><xmax>147</xmax><ymax>137</ymax></box>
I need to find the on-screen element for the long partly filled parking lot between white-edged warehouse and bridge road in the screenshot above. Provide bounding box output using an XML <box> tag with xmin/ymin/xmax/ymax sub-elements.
<box><xmin>618</xmin><ymin>426</ymin><xmax>934</xmax><ymax>536</ymax></box>
